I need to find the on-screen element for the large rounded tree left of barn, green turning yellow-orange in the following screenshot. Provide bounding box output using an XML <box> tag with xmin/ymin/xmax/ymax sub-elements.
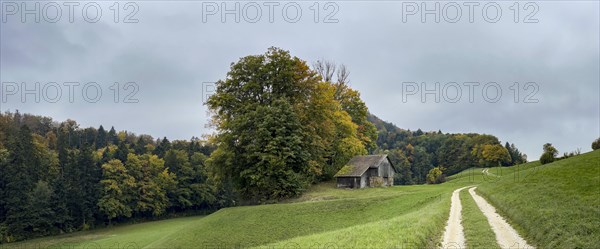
<box><xmin>206</xmin><ymin>48</ymin><xmax>374</xmax><ymax>202</ymax></box>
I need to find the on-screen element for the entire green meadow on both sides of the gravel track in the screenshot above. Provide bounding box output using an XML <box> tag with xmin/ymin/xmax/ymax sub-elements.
<box><xmin>0</xmin><ymin>151</ymin><xmax>600</xmax><ymax>249</ymax></box>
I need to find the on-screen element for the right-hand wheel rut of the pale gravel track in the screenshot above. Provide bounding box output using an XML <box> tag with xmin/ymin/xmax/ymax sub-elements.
<box><xmin>468</xmin><ymin>187</ymin><xmax>534</xmax><ymax>248</ymax></box>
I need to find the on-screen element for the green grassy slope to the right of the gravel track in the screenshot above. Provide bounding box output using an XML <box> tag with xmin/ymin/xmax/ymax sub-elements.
<box><xmin>477</xmin><ymin>150</ymin><xmax>600</xmax><ymax>248</ymax></box>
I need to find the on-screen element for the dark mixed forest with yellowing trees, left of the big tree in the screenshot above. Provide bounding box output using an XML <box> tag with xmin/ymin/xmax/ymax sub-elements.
<box><xmin>0</xmin><ymin>111</ymin><xmax>226</xmax><ymax>242</ymax></box>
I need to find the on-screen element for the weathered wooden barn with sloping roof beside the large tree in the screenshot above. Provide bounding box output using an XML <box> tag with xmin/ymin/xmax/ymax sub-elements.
<box><xmin>335</xmin><ymin>155</ymin><xmax>396</xmax><ymax>188</ymax></box>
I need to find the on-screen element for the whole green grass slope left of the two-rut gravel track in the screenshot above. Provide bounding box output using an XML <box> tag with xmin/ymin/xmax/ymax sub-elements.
<box><xmin>7</xmin><ymin>184</ymin><xmax>455</xmax><ymax>248</ymax></box>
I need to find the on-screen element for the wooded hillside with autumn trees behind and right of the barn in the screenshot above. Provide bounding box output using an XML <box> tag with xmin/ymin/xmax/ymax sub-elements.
<box><xmin>369</xmin><ymin>115</ymin><xmax>527</xmax><ymax>185</ymax></box>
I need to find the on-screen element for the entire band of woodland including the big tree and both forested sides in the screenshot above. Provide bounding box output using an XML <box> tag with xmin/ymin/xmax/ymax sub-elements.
<box><xmin>0</xmin><ymin>48</ymin><xmax>526</xmax><ymax>242</ymax></box>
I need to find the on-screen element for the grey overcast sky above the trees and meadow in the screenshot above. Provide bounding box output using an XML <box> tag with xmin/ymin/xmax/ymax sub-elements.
<box><xmin>0</xmin><ymin>1</ymin><xmax>600</xmax><ymax>160</ymax></box>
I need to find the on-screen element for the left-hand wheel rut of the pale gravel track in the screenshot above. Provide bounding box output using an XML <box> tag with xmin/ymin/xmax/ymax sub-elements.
<box><xmin>442</xmin><ymin>187</ymin><xmax>468</xmax><ymax>249</ymax></box>
